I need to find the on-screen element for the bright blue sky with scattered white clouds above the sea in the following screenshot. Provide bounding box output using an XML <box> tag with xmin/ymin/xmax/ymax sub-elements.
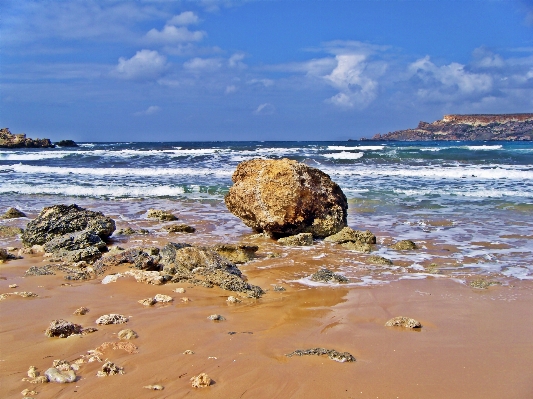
<box><xmin>0</xmin><ymin>0</ymin><xmax>533</xmax><ymax>142</ymax></box>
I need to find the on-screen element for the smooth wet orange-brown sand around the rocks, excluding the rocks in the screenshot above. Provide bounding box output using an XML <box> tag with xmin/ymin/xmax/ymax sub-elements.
<box><xmin>0</xmin><ymin>208</ymin><xmax>533</xmax><ymax>399</ymax></box>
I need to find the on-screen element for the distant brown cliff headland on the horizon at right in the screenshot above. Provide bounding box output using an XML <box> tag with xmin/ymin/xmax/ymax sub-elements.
<box><xmin>372</xmin><ymin>114</ymin><xmax>533</xmax><ymax>141</ymax></box>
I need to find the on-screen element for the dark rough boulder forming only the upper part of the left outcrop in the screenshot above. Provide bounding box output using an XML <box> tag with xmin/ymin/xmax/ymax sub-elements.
<box><xmin>22</xmin><ymin>205</ymin><xmax>115</xmax><ymax>247</ymax></box>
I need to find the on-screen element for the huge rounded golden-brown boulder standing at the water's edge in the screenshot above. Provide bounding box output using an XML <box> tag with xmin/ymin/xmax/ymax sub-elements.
<box><xmin>225</xmin><ymin>159</ymin><xmax>348</xmax><ymax>237</ymax></box>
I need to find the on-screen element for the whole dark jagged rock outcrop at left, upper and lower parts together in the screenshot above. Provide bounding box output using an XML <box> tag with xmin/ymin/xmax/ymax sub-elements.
<box><xmin>22</xmin><ymin>205</ymin><xmax>115</xmax><ymax>262</ymax></box>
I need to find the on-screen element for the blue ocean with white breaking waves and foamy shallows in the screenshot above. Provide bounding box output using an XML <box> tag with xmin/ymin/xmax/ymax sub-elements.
<box><xmin>0</xmin><ymin>141</ymin><xmax>533</xmax><ymax>285</ymax></box>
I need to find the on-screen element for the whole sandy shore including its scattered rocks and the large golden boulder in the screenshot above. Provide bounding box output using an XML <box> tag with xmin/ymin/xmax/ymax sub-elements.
<box><xmin>0</xmin><ymin>160</ymin><xmax>533</xmax><ymax>399</ymax></box>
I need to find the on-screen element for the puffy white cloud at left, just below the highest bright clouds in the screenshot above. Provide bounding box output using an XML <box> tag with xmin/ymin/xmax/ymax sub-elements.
<box><xmin>111</xmin><ymin>50</ymin><xmax>168</xmax><ymax>80</ymax></box>
